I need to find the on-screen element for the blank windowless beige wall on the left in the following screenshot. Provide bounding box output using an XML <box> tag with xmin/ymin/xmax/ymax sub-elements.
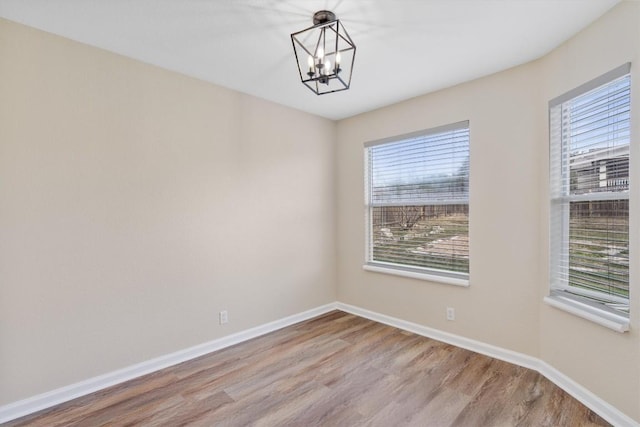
<box><xmin>0</xmin><ymin>19</ymin><xmax>336</xmax><ymax>405</ymax></box>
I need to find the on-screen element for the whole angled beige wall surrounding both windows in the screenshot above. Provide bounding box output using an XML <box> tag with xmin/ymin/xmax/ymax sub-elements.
<box><xmin>337</xmin><ymin>2</ymin><xmax>640</xmax><ymax>420</ymax></box>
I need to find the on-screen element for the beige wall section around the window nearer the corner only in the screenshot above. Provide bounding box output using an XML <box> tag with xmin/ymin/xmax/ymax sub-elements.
<box><xmin>337</xmin><ymin>60</ymin><xmax>544</xmax><ymax>355</ymax></box>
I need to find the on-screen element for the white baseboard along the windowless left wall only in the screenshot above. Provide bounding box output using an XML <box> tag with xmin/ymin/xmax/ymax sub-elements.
<box><xmin>0</xmin><ymin>303</ymin><xmax>336</xmax><ymax>424</ymax></box>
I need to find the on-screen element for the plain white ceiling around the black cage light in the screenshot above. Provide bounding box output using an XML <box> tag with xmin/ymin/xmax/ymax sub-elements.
<box><xmin>0</xmin><ymin>0</ymin><xmax>619</xmax><ymax>119</ymax></box>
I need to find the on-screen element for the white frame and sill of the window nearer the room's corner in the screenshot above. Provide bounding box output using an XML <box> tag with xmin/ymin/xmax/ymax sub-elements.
<box><xmin>363</xmin><ymin>120</ymin><xmax>471</xmax><ymax>287</ymax></box>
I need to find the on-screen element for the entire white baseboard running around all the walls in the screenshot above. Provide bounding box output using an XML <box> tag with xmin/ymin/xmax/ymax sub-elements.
<box><xmin>0</xmin><ymin>302</ymin><xmax>640</xmax><ymax>427</ymax></box>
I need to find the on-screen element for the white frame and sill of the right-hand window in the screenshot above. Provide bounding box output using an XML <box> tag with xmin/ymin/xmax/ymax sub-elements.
<box><xmin>544</xmin><ymin>63</ymin><xmax>633</xmax><ymax>332</ymax></box>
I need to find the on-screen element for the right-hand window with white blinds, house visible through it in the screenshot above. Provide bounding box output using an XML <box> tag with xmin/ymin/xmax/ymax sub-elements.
<box><xmin>549</xmin><ymin>64</ymin><xmax>631</xmax><ymax>332</ymax></box>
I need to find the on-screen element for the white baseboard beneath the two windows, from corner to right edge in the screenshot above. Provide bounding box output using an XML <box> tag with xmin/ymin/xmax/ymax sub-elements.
<box><xmin>336</xmin><ymin>302</ymin><xmax>640</xmax><ymax>427</ymax></box>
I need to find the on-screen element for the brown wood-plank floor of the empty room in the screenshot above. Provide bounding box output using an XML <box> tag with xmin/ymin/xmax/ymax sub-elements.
<box><xmin>6</xmin><ymin>311</ymin><xmax>608</xmax><ymax>427</ymax></box>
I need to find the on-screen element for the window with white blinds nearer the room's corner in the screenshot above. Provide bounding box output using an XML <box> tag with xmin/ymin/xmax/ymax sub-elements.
<box><xmin>365</xmin><ymin>122</ymin><xmax>469</xmax><ymax>286</ymax></box>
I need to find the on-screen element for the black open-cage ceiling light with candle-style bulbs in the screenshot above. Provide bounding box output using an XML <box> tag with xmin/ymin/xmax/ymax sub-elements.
<box><xmin>291</xmin><ymin>10</ymin><xmax>356</xmax><ymax>95</ymax></box>
